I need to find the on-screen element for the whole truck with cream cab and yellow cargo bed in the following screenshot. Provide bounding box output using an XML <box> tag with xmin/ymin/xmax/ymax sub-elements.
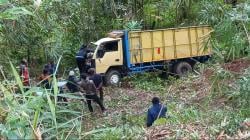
<box><xmin>91</xmin><ymin>25</ymin><xmax>213</xmax><ymax>85</ymax></box>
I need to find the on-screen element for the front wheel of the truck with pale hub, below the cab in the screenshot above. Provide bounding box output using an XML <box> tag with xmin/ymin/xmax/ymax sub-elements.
<box><xmin>105</xmin><ymin>70</ymin><xmax>121</xmax><ymax>86</ymax></box>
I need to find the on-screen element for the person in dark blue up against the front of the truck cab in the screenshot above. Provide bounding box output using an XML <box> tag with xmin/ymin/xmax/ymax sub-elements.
<box><xmin>76</xmin><ymin>44</ymin><xmax>87</xmax><ymax>74</ymax></box>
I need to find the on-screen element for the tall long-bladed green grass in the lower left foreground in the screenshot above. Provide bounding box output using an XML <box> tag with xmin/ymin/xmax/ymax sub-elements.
<box><xmin>0</xmin><ymin>59</ymin><xmax>87</xmax><ymax>139</ymax></box>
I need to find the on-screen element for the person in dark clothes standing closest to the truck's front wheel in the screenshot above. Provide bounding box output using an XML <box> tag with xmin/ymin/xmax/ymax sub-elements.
<box><xmin>88</xmin><ymin>68</ymin><xmax>103</xmax><ymax>102</ymax></box>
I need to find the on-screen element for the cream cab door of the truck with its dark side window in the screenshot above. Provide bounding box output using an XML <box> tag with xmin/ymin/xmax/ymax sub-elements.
<box><xmin>95</xmin><ymin>40</ymin><xmax>123</xmax><ymax>73</ymax></box>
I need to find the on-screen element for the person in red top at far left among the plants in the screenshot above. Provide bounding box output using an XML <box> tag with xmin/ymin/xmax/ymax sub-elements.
<box><xmin>19</xmin><ymin>59</ymin><xmax>30</xmax><ymax>86</ymax></box>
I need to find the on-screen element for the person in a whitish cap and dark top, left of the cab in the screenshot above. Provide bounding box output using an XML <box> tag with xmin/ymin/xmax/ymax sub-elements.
<box><xmin>66</xmin><ymin>71</ymin><xmax>78</xmax><ymax>93</ymax></box>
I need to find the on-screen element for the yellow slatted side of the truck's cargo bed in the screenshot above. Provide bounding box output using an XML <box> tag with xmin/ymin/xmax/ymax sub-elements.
<box><xmin>129</xmin><ymin>26</ymin><xmax>212</xmax><ymax>64</ymax></box>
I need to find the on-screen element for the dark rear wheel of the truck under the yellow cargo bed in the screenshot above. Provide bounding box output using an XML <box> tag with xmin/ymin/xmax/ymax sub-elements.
<box><xmin>174</xmin><ymin>61</ymin><xmax>192</xmax><ymax>76</ymax></box>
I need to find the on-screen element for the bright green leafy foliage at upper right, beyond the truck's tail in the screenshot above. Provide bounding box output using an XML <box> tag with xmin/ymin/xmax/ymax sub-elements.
<box><xmin>200</xmin><ymin>2</ymin><xmax>250</xmax><ymax>61</ymax></box>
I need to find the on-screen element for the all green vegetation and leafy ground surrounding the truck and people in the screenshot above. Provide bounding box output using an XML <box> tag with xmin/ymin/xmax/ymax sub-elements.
<box><xmin>0</xmin><ymin>0</ymin><xmax>250</xmax><ymax>139</ymax></box>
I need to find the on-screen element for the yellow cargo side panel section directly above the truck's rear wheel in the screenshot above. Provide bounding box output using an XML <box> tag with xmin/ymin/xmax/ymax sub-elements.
<box><xmin>175</xmin><ymin>29</ymin><xmax>190</xmax><ymax>58</ymax></box>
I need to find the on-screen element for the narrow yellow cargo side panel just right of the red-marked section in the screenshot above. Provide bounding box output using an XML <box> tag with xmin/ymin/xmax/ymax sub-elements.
<box><xmin>164</xmin><ymin>30</ymin><xmax>175</xmax><ymax>60</ymax></box>
